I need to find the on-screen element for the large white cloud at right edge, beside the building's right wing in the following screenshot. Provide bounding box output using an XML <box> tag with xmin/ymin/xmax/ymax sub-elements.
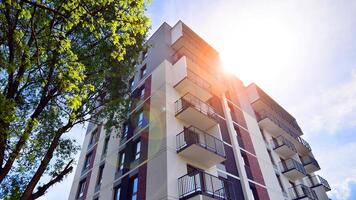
<box><xmin>292</xmin><ymin>71</ymin><xmax>356</xmax><ymax>134</ymax></box>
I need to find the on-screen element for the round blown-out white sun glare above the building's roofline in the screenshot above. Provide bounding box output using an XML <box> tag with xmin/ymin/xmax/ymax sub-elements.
<box><xmin>219</xmin><ymin>17</ymin><xmax>297</xmax><ymax>83</ymax></box>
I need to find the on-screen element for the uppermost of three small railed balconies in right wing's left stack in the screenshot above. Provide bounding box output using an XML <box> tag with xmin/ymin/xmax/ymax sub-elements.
<box><xmin>271</xmin><ymin>136</ymin><xmax>297</xmax><ymax>159</ymax></box>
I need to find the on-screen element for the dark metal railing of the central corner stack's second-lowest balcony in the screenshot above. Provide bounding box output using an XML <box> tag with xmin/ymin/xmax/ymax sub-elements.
<box><xmin>176</xmin><ymin>126</ymin><xmax>226</xmax><ymax>157</ymax></box>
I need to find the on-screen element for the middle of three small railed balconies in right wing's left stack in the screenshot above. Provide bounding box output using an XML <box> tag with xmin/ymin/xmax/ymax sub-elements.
<box><xmin>279</xmin><ymin>159</ymin><xmax>306</xmax><ymax>181</ymax></box>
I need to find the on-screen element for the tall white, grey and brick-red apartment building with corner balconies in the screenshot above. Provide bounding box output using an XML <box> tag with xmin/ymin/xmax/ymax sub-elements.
<box><xmin>69</xmin><ymin>21</ymin><xmax>330</xmax><ymax>200</ymax></box>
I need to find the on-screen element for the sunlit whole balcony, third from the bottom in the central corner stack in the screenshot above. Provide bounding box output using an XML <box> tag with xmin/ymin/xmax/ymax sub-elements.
<box><xmin>175</xmin><ymin>93</ymin><xmax>218</xmax><ymax>130</ymax></box>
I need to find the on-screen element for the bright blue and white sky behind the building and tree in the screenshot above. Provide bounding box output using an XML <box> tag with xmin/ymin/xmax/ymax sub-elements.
<box><xmin>41</xmin><ymin>0</ymin><xmax>356</xmax><ymax>200</ymax></box>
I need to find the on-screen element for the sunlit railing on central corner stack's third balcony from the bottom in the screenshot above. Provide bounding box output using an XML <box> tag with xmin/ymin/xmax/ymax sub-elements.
<box><xmin>175</xmin><ymin>93</ymin><xmax>217</xmax><ymax>119</ymax></box>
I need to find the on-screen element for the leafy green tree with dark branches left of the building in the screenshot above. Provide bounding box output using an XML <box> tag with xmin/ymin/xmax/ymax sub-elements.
<box><xmin>0</xmin><ymin>0</ymin><xmax>149</xmax><ymax>199</ymax></box>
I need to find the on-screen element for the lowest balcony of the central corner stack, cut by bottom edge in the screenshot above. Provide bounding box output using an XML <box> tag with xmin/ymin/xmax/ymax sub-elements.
<box><xmin>178</xmin><ymin>170</ymin><xmax>231</xmax><ymax>200</ymax></box>
